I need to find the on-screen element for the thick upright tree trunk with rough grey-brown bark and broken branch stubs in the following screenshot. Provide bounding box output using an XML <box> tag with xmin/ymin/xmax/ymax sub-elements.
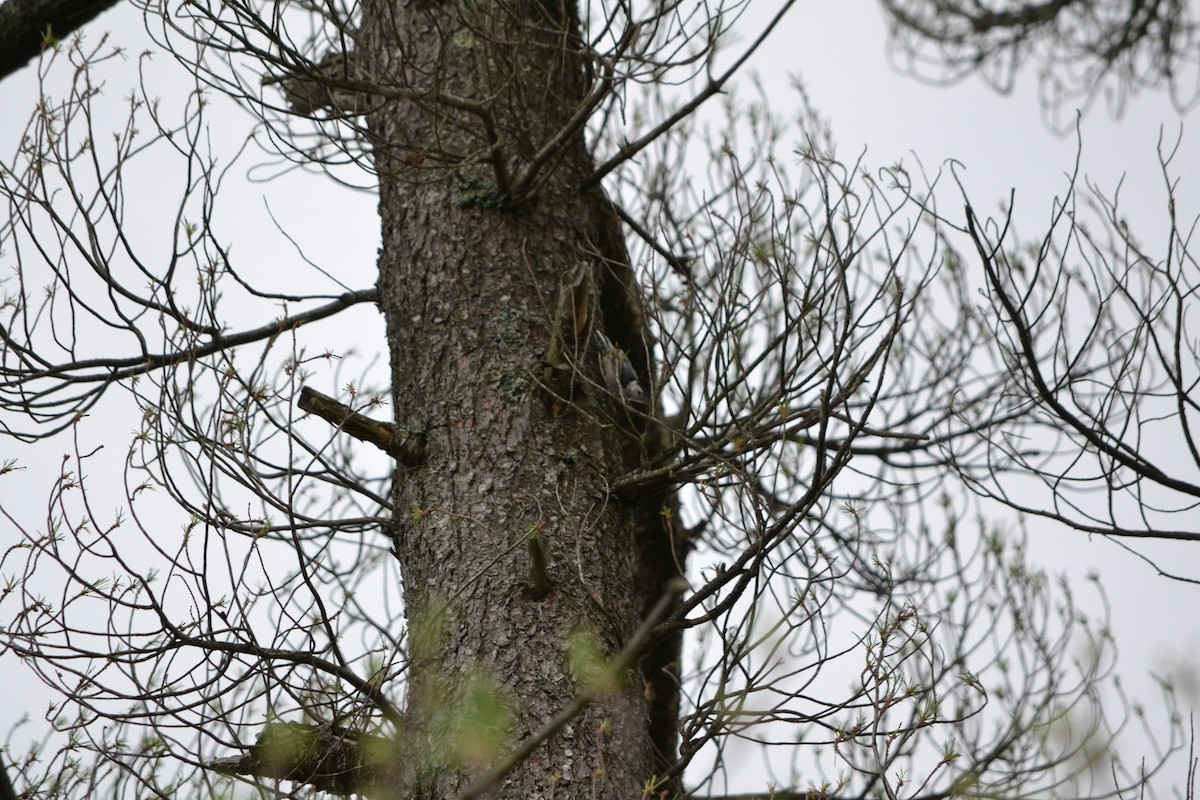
<box><xmin>359</xmin><ymin>0</ymin><xmax>673</xmax><ymax>799</ymax></box>
